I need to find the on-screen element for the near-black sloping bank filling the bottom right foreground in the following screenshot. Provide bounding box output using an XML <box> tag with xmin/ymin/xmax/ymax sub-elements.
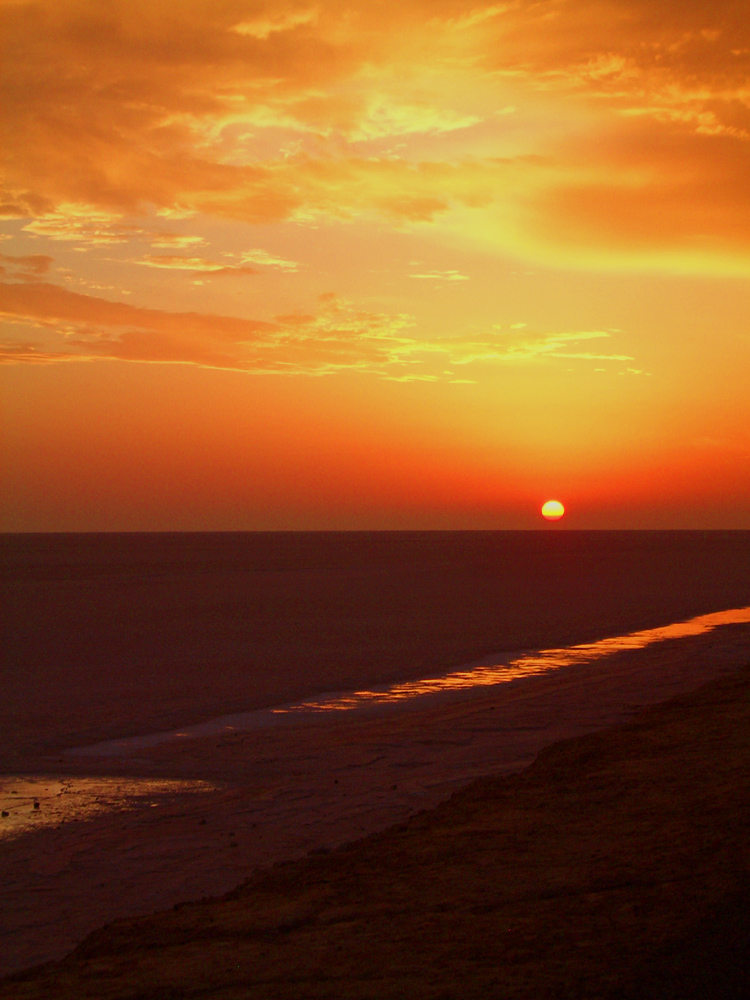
<box><xmin>5</xmin><ymin>667</ymin><xmax>750</xmax><ymax>1000</ymax></box>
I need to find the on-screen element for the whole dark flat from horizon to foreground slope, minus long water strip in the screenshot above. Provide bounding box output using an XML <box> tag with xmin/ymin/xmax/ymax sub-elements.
<box><xmin>0</xmin><ymin>532</ymin><xmax>750</xmax><ymax>971</ymax></box>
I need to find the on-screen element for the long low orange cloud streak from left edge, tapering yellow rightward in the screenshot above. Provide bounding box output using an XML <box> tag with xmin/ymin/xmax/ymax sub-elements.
<box><xmin>0</xmin><ymin>282</ymin><xmax>632</xmax><ymax>381</ymax></box>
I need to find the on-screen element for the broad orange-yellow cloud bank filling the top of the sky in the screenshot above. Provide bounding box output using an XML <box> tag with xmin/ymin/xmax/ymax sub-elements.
<box><xmin>1</xmin><ymin>0</ymin><xmax>750</xmax><ymax>267</ymax></box>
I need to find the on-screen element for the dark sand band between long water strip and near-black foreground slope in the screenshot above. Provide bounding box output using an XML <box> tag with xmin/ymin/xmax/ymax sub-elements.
<box><xmin>0</xmin><ymin>625</ymin><xmax>750</xmax><ymax>973</ymax></box>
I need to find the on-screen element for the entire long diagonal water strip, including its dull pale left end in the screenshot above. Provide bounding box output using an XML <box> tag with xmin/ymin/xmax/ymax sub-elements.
<box><xmin>67</xmin><ymin>607</ymin><xmax>750</xmax><ymax>757</ymax></box>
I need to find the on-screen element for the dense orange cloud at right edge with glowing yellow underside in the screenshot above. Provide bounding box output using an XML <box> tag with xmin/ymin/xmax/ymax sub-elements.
<box><xmin>533</xmin><ymin>120</ymin><xmax>750</xmax><ymax>269</ymax></box>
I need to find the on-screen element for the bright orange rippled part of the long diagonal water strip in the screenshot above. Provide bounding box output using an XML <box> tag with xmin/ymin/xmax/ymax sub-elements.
<box><xmin>272</xmin><ymin>608</ymin><xmax>750</xmax><ymax>713</ymax></box>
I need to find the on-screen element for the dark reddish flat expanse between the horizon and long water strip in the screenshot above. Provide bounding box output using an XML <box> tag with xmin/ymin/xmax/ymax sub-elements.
<box><xmin>5</xmin><ymin>531</ymin><xmax>750</xmax><ymax>756</ymax></box>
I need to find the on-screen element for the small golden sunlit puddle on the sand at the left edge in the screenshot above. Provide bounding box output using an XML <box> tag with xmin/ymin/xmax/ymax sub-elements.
<box><xmin>0</xmin><ymin>775</ymin><xmax>215</xmax><ymax>840</ymax></box>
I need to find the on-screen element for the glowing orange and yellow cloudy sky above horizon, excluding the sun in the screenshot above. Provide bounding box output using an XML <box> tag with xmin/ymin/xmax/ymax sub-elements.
<box><xmin>0</xmin><ymin>0</ymin><xmax>750</xmax><ymax>531</ymax></box>
